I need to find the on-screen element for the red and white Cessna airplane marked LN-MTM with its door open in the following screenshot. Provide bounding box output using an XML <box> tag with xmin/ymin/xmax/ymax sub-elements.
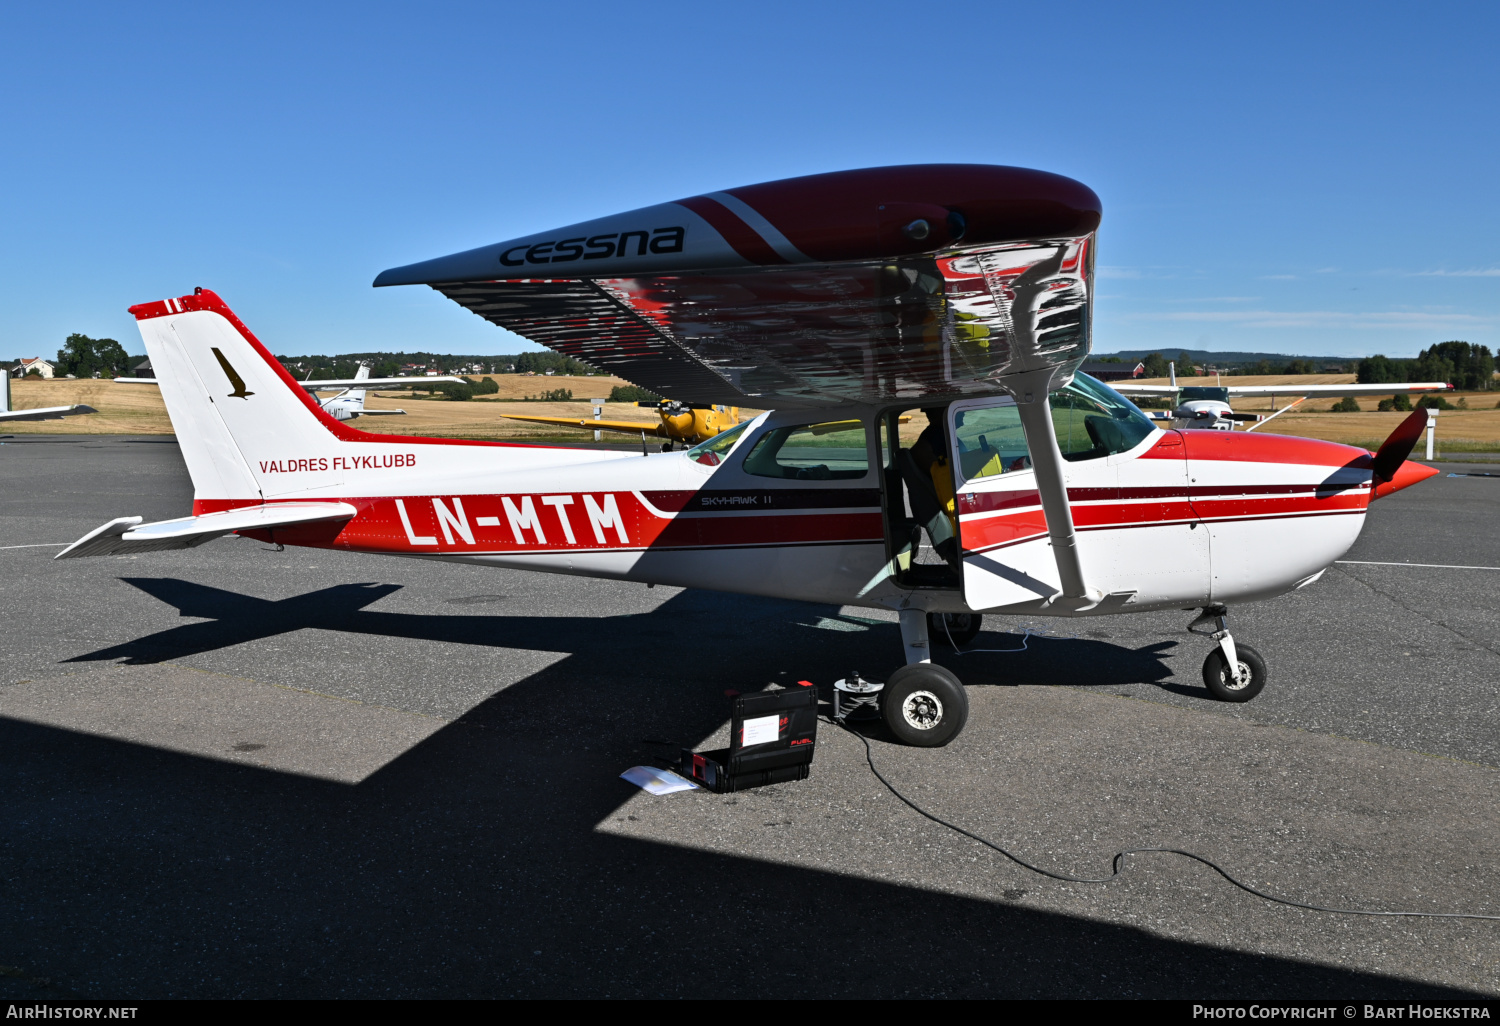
<box><xmin>57</xmin><ymin>165</ymin><xmax>1436</xmax><ymax>746</ymax></box>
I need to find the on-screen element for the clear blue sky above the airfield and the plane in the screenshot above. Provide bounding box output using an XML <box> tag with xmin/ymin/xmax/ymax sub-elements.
<box><xmin>0</xmin><ymin>0</ymin><xmax>1500</xmax><ymax>359</ymax></box>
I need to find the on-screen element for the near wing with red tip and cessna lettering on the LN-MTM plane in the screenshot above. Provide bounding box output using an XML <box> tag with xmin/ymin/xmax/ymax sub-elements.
<box><xmin>375</xmin><ymin>165</ymin><xmax>1101</xmax><ymax>408</ymax></box>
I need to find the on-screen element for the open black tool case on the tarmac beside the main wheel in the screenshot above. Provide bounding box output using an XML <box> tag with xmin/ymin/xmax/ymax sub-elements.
<box><xmin>678</xmin><ymin>684</ymin><xmax>818</xmax><ymax>795</ymax></box>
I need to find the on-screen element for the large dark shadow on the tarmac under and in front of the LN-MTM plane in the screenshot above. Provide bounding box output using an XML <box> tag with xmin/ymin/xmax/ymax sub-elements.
<box><xmin>0</xmin><ymin>579</ymin><xmax>1460</xmax><ymax>999</ymax></box>
